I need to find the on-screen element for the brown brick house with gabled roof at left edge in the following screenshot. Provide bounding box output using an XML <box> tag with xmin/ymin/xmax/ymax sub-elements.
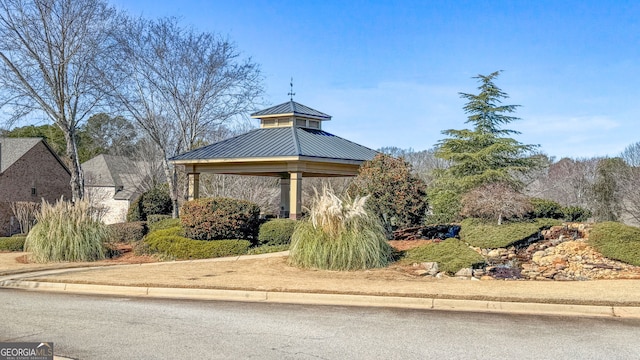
<box><xmin>0</xmin><ymin>138</ymin><xmax>71</xmax><ymax>236</ymax></box>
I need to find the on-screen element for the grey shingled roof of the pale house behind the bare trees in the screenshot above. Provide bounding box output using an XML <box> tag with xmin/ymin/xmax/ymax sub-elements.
<box><xmin>81</xmin><ymin>154</ymin><xmax>144</xmax><ymax>200</ymax></box>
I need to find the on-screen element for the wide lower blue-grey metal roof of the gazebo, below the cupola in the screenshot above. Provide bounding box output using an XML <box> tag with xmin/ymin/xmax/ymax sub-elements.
<box><xmin>170</xmin><ymin>125</ymin><xmax>377</xmax><ymax>162</ymax></box>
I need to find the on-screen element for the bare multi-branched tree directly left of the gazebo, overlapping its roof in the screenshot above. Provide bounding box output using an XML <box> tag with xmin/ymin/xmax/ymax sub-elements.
<box><xmin>104</xmin><ymin>18</ymin><xmax>262</xmax><ymax>217</ymax></box>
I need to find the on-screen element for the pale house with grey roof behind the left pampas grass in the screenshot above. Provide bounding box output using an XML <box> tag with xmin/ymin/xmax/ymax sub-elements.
<box><xmin>81</xmin><ymin>154</ymin><xmax>147</xmax><ymax>224</ymax></box>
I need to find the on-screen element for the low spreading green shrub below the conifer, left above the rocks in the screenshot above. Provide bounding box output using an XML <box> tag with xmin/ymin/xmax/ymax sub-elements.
<box><xmin>460</xmin><ymin>219</ymin><xmax>561</xmax><ymax>249</ymax></box>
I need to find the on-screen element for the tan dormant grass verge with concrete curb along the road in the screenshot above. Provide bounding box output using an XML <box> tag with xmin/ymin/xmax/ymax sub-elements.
<box><xmin>0</xmin><ymin>253</ymin><xmax>640</xmax><ymax>319</ymax></box>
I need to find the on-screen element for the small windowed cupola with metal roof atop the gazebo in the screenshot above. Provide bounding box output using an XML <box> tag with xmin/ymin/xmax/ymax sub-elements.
<box><xmin>251</xmin><ymin>100</ymin><xmax>331</xmax><ymax>130</ymax></box>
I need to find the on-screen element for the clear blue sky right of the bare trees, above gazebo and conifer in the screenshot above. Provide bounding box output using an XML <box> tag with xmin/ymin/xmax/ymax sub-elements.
<box><xmin>112</xmin><ymin>0</ymin><xmax>640</xmax><ymax>158</ymax></box>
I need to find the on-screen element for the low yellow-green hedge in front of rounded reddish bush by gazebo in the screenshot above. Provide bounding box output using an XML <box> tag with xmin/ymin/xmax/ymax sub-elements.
<box><xmin>144</xmin><ymin>227</ymin><xmax>251</xmax><ymax>260</ymax></box>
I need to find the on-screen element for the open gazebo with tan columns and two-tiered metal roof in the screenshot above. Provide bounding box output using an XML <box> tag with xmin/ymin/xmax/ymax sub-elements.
<box><xmin>170</xmin><ymin>100</ymin><xmax>377</xmax><ymax>219</ymax></box>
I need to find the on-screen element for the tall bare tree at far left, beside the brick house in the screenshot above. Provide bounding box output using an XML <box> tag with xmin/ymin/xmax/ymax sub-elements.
<box><xmin>0</xmin><ymin>0</ymin><xmax>114</xmax><ymax>201</ymax></box>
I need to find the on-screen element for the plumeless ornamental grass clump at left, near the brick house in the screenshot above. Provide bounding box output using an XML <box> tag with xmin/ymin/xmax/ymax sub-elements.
<box><xmin>24</xmin><ymin>199</ymin><xmax>109</xmax><ymax>263</ymax></box>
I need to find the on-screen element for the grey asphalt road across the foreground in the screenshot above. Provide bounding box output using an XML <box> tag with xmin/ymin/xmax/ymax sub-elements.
<box><xmin>0</xmin><ymin>289</ymin><xmax>640</xmax><ymax>360</ymax></box>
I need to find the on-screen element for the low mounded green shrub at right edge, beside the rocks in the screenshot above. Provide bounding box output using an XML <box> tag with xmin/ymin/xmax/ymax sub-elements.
<box><xmin>589</xmin><ymin>221</ymin><xmax>640</xmax><ymax>266</ymax></box>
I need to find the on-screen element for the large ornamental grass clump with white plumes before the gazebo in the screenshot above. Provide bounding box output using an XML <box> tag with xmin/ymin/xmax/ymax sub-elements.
<box><xmin>289</xmin><ymin>188</ymin><xmax>392</xmax><ymax>270</ymax></box>
